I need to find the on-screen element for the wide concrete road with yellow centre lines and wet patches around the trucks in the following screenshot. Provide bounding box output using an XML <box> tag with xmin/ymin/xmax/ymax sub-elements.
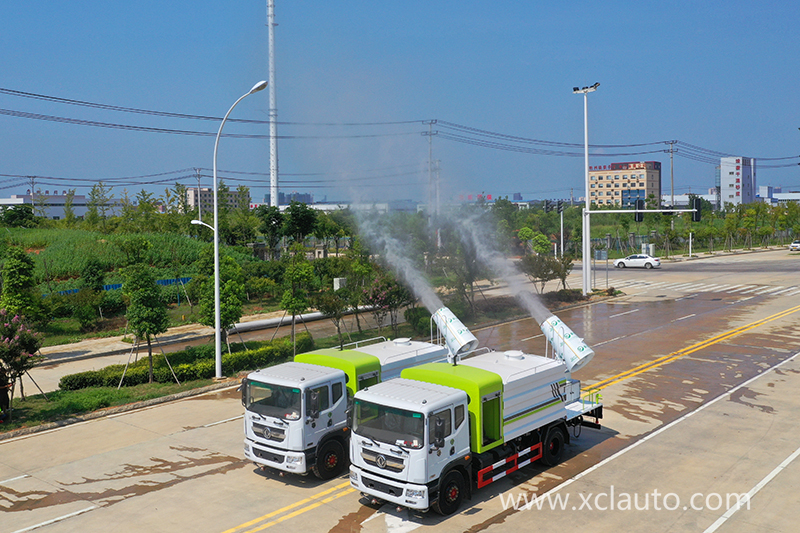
<box><xmin>0</xmin><ymin>251</ymin><xmax>800</xmax><ymax>533</ymax></box>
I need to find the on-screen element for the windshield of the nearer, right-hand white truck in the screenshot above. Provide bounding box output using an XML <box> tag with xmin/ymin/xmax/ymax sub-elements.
<box><xmin>353</xmin><ymin>399</ymin><xmax>425</xmax><ymax>448</ymax></box>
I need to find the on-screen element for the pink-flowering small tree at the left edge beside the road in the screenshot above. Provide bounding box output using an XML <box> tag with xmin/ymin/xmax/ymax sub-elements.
<box><xmin>0</xmin><ymin>309</ymin><xmax>44</xmax><ymax>421</ymax></box>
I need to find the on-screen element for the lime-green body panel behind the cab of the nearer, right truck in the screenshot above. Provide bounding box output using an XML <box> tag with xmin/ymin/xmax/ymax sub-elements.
<box><xmin>400</xmin><ymin>363</ymin><xmax>503</xmax><ymax>453</ymax></box>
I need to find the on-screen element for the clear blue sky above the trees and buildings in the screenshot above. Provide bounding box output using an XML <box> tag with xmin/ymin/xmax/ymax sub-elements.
<box><xmin>0</xmin><ymin>0</ymin><xmax>800</xmax><ymax>205</ymax></box>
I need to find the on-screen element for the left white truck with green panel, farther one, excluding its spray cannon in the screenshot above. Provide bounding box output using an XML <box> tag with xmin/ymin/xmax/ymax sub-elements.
<box><xmin>242</xmin><ymin>332</ymin><xmax>448</xmax><ymax>479</ymax></box>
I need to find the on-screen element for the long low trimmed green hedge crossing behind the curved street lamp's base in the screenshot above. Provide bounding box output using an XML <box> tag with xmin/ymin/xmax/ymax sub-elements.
<box><xmin>58</xmin><ymin>333</ymin><xmax>314</xmax><ymax>390</ymax></box>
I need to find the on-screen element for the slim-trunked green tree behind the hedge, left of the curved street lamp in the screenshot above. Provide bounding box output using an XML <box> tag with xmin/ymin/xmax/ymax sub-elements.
<box><xmin>122</xmin><ymin>264</ymin><xmax>169</xmax><ymax>383</ymax></box>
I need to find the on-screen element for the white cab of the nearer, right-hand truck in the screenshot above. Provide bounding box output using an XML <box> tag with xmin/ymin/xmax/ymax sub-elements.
<box><xmin>350</xmin><ymin>378</ymin><xmax>470</xmax><ymax>509</ymax></box>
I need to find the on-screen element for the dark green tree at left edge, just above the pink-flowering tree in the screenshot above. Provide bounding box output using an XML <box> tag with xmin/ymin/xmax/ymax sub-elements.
<box><xmin>0</xmin><ymin>246</ymin><xmax>43</xmax><ymax>322</ymax></box>
